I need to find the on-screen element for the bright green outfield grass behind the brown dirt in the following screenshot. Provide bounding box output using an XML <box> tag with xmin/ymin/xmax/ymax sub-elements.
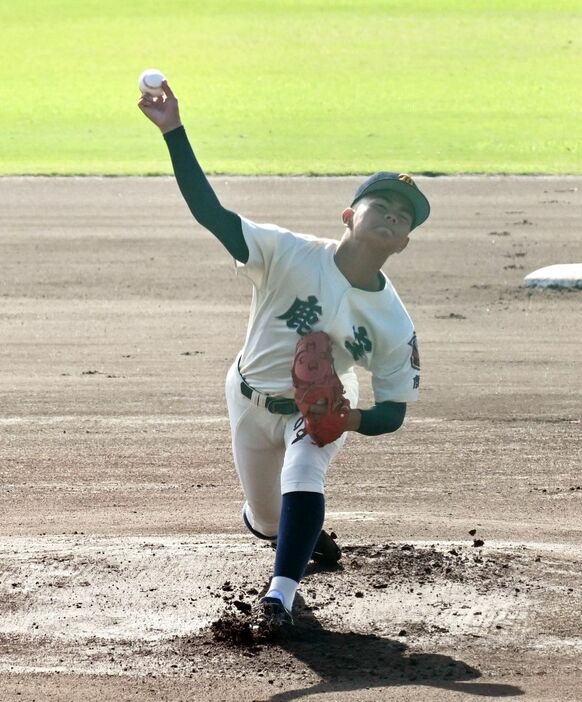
<box><xmin>0</xmin><ymin>0</ymin><xmax>582</xmax><ymax>175</ymax></box>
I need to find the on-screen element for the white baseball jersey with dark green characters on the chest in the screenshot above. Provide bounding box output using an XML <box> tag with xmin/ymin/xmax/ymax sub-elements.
<box><xmin>237</xmin><ymin>217</ymin><xmax>420</xmax><ymax>402</ymax></box>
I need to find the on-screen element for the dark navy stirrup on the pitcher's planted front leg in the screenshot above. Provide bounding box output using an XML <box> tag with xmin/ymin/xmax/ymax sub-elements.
<box><xmin>274</xmin><ymin>492</ymin><xmax>325</xmax><ymax>583</ymax></box>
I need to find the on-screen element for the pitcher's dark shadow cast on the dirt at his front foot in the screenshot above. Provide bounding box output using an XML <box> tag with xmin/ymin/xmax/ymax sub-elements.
<box><xmin>269</xmin><ymin>596</ymin><xmax>524</xmax><ymax>702</ymax></box>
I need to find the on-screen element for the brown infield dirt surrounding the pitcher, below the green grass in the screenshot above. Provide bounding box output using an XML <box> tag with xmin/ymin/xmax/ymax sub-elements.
<box><xmin>0</xmin><ymin>177</ymin><xmax>582</xmax><ymax>702</ymax></box>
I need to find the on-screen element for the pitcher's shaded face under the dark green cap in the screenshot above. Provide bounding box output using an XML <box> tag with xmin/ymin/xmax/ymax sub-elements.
<box><xmin>351</xmin><ymin>192</ymin><xmax>414</xmax><ymax>255</ymax></box>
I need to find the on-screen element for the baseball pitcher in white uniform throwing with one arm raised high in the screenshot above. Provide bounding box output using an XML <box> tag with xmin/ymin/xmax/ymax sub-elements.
<box><xmin>138</xmin><ymin>82</ymin><xmax>430</xmax><ymax>629</ymax></box>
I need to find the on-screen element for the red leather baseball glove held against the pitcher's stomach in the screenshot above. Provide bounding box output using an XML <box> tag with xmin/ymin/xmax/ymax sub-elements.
<box><xmin>291</xmin><ymin>332</ymin><xmax>350</xmax><ymax>446</ymax></box>
